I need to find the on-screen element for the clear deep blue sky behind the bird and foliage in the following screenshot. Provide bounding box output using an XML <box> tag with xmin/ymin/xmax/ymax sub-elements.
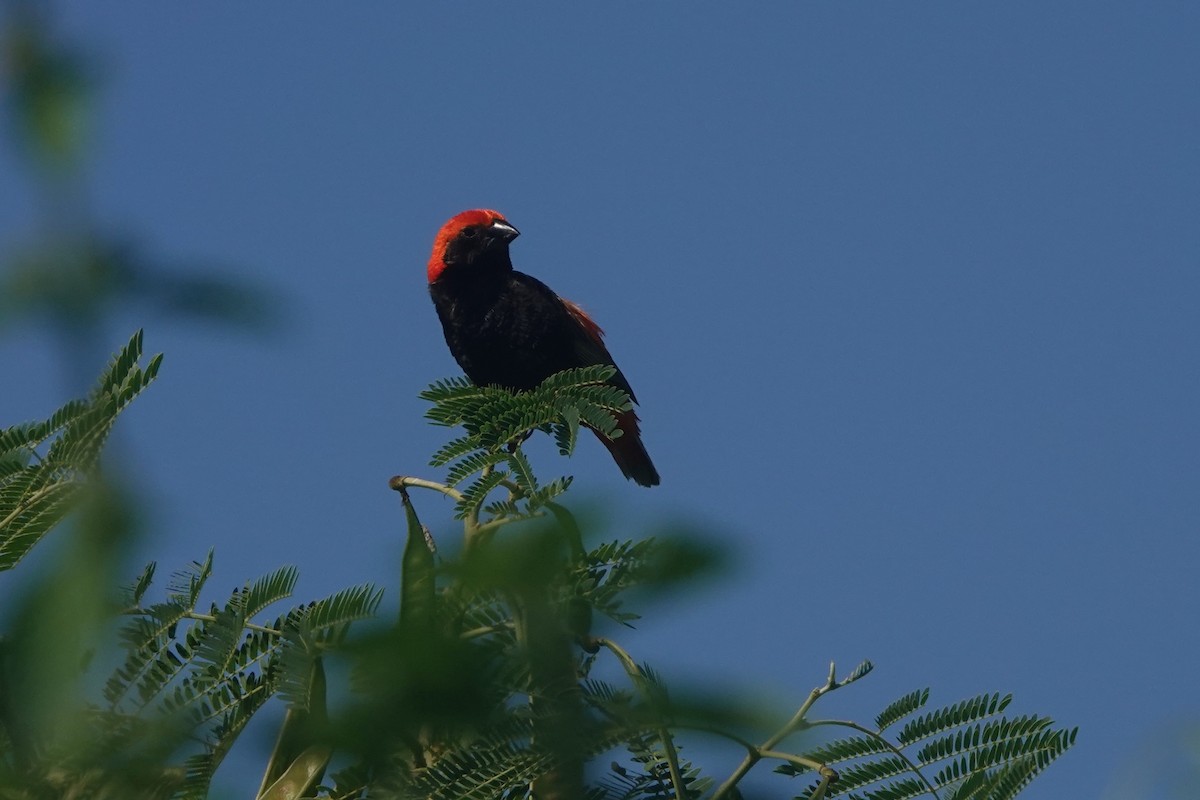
<box><xmin>0</xmin><ymin>1</ymin><xmax>1200</xmax><ymax>798</ymax></box>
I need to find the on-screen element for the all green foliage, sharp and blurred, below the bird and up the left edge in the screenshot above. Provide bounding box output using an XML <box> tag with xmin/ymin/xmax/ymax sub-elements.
<box><xmin>0</xmin><ymin>0</ymin><xmax>1075</xmax><ymax>800</ymax></box>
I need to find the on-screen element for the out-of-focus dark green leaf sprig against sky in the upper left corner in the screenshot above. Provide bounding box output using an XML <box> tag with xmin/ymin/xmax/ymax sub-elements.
<box><xmin>0</xmin><ymin>0</ymin><xmax>278</xmax><ymax>385</ymax></box>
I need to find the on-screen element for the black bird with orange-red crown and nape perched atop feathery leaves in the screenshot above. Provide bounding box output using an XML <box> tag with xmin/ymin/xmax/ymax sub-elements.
<box><xmin>427</xmin><ymin>209</ymin><xmax>659</xmax><ymax>486</ymax></box>
